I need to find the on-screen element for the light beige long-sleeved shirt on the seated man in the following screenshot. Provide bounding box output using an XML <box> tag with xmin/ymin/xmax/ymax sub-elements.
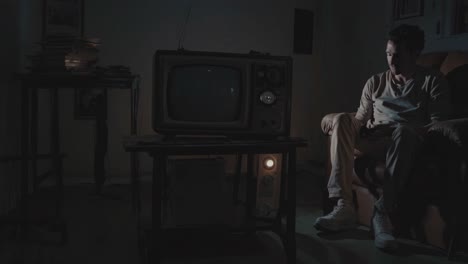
<box><xmin>356</xmin><ymin>67</ymin><xmax>449</xmax><ymax>128</ymax></box>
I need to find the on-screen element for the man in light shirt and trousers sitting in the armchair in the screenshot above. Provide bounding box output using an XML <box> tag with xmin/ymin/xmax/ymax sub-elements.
<box><xmin>314</xmin><ymin>25</ymin><xmax>449</xmax><ymax>250</ymax></box>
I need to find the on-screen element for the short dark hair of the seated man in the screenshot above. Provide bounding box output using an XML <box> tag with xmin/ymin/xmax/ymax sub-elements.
<box><xmin>388</xmin><ymin>24</ymin><xmax>424</xmax><ymax>53</ymax></box>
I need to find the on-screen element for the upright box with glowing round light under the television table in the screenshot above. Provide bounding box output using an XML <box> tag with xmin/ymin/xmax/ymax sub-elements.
<box><xmin>255</xmin><ymin>154</ymin><xmax>282</xmax><ymax>218</ymax></box>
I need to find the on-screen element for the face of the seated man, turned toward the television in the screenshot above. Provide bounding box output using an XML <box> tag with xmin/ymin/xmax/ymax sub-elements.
<box><xmin>386</xmin><ymin>40</ymin><xmax>417</xmax><ymax>75</ymax></box>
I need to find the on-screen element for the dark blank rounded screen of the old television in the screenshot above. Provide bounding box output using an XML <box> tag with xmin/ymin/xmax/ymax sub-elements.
<box><xmin>167</xmin><ymin>64</ymin><xmax>242</xmax><ymax>122</ymax></box>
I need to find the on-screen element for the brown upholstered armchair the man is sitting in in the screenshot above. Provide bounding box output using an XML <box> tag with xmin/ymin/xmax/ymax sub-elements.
<box><xmin>321</xmin><ymin>51</ymin><xmax>468</xmax><ymax>256</ymax></box>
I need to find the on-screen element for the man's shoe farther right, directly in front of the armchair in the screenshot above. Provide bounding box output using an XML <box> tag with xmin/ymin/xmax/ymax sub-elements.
<box><xmin>371</xmin><ymin>208</ymin><xmax>398</xmax><ymax>251</ymax></box>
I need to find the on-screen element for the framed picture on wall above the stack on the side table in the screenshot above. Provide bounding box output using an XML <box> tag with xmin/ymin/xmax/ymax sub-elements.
<box><xmin>42</xmin><ymin>0</ymin><xmax>84</xmax><ymax>38</ymax></box>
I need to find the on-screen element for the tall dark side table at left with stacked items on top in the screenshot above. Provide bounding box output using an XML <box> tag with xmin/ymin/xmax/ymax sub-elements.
<box><xmin>9</xmin><ymin>72</ymin><xmax>139</xmax><ymax>243</ymax></box>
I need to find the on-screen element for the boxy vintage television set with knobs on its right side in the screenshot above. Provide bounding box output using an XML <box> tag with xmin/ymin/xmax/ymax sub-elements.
<box><xmin>152</xmin><ymin>50</ymin><xmax>292</xmax><ymax>137</ymax></box>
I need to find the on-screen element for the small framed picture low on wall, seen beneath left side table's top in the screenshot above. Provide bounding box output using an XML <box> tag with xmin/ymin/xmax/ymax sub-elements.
<box><xmin>74</xmin><ymin>88</ymin><xmax>107</xmax><ymax>120</ymax></box>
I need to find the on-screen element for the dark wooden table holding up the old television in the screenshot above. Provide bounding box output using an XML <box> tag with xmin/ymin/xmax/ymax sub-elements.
<box><xmin>123</xmin><ymin>135</ymin><xmax>307</xmax><ymax>264</ymax></box>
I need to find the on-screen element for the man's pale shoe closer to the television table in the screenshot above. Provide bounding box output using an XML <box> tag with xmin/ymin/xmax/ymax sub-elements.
<box><xmin>314</xmin><ymin>199</ymin><xmax>356</xmax><ymax>232</ymax></box>
